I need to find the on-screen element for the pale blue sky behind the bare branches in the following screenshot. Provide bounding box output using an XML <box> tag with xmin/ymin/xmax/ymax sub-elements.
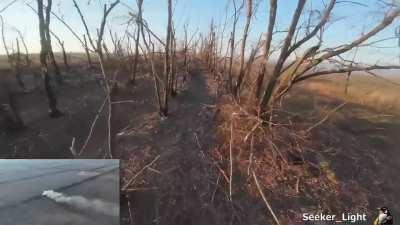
<box><xmin>0</xmin><ymin>0</ymin><xmax>400</xmax><ymax>64</ymax></box>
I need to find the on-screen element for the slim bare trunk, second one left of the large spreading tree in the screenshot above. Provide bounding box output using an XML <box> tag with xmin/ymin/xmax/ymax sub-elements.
<box><xmin>233</xmin><ymin>0</ymin><xmax>253</xmax><ymax>97</ymax></box>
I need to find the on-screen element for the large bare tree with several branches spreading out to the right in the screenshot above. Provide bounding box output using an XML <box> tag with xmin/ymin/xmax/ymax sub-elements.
<box><xmin>259</xmin><ymin>0</ymin><xmax>400</xmax><ymax>118</ymax></box>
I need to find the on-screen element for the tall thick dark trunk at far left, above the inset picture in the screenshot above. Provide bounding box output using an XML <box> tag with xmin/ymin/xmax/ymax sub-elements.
<box><xmin>37</xmin><ymin>0</ymin><xmax>61</xmax><ymax>118</ymax></box>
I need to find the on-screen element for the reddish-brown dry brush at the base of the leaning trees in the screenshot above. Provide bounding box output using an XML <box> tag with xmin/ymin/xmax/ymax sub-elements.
<box><xmin>214</xmin><ymin>96</ymin><xmax>340</xmax><ymax>224</ymax></box>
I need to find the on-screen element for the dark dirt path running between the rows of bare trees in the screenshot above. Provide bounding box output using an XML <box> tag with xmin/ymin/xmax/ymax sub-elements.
<box><xmin>117</xmin><ymin>62</ymin><xmax>238</xmax><ymax>225</ymax></box>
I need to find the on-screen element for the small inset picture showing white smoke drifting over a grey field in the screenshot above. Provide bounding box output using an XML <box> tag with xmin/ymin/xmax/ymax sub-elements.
<box><xmin>0</xmin><ymin>160</ymin><xmax>119</xmax><ymax>225</ymax></box>
